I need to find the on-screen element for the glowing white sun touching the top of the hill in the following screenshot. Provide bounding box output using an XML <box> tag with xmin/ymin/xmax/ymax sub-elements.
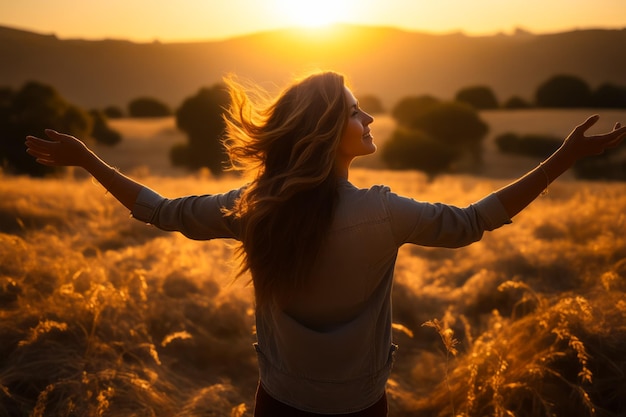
<box><xmin>275</xmin><ymin>0</ymin><xmax>353</xmax><ymax>27</ymax></box>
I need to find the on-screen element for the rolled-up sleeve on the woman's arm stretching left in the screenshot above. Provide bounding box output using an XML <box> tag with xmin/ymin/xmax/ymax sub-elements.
<box><xmin>131</xmin><ymin>188</ymin><xmax>241</xmax><ymax>240</ymax></box>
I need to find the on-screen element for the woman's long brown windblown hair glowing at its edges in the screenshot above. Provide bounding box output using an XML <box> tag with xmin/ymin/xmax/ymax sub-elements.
<box><xmin>224</xmin><ymin>72</ymin><xmax>348</xmax><ymax>307</ymax></box>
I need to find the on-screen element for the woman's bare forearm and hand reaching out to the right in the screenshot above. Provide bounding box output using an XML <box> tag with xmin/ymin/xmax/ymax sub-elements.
<box><xmin>496</xmin><ymin>115</ymin><xmax>626</xmax><ymax>218</ymax></box>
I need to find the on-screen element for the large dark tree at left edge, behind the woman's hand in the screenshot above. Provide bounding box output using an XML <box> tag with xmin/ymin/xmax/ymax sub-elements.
<box><xmin>0</xmin><ymin>82</ymin><xmax>92</xmax><ymax>176</ymax></box>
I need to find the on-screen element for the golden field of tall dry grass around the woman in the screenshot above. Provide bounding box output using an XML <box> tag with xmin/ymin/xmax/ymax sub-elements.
<box><xmin>0</xmin><ymin>113</ymin><xmax>626</xmax><ymax>417</ymax></box>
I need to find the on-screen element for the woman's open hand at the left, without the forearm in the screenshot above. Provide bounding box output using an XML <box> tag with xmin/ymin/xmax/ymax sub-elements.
<box><xmin>26</xmin><ymin>129</ymin><xmax>91</xmax><ymax>167</ymax></box>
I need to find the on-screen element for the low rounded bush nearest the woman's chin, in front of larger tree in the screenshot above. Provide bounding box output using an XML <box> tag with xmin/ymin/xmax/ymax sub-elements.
<box><xmin>382</xmin><ymin>127</ymin><xmax>458</xmax><ymax>179</ymax></box>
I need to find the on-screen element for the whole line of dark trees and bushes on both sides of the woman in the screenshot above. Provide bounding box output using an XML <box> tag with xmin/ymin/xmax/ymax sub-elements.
<box><xmin>0</xmin><ymin>75</ymin><xmax>626</xmax><ymax>179</ymax></box>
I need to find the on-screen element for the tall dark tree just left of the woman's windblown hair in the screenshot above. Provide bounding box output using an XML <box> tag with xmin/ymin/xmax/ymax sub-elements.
<box><xmin>170</xmin><ymin>84</ymin><xmax>230</xmax><ymax>175</ymax></box>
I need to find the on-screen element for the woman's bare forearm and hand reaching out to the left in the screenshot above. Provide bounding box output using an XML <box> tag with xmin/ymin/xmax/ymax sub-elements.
<box><xmin>26</xmin><ymin>129</ymin><xmax>143</xmax><ymax>210</ymax></box>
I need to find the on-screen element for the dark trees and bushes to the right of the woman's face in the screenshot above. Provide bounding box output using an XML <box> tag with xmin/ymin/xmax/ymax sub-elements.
<box><xmin>382</xmin><ymin>75</ymin><xmax>626</xmax><ymax>180</ymax></box>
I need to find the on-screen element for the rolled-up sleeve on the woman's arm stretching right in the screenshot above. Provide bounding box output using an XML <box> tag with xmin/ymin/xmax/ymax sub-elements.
<box><xmin>386</xmin><ymin>192</ymin><xmax>511</xmax><ymax>248</ymax></box>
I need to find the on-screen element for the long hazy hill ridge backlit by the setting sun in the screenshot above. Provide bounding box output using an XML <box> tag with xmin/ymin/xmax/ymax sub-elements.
<box><xmin>0</xmin><ymin>25</ymin><xmax>626</xmax><ymax>107</ymax></box>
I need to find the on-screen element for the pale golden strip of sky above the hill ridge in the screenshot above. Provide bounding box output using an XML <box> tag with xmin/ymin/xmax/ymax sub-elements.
<box><xmin>0</xmin><ymin>0</ymin><xmax>626</xmax><ymax>42</ymax></box>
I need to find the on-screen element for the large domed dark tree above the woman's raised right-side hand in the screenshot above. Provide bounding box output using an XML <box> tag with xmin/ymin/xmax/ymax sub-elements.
<box><xmin>535</xmin><ymin>75</ymin><xmax>593</xmax><ymax>108</ymax></box>
